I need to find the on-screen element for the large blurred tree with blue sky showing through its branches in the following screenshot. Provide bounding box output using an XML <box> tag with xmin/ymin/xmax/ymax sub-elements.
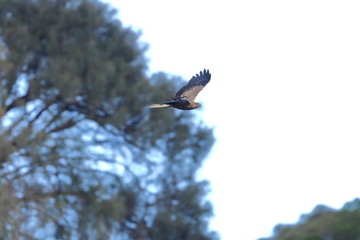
<box><xmin>0</xmin><ymin>0</ymin><xmax>217</xmax><ymax>240</ymax></box>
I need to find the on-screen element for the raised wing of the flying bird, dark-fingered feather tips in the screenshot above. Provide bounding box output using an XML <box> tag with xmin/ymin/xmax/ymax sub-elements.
<box><xmin>175</xmin><ymin>69</ymin><xmax>211</xmax><ymax>102</ymax></box>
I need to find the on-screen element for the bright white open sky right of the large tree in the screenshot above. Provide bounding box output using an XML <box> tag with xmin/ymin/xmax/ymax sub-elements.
<box><xmin>104</xmin><ymin>0</ymin><xmax>360</xmax><ymax>240</ymax></box>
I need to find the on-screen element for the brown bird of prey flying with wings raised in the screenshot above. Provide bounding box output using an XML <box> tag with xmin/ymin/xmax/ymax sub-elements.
<box><xmin>150</xmin><ymin>69</ymin><xmax>211</xmax><ymax>110</ymax></box>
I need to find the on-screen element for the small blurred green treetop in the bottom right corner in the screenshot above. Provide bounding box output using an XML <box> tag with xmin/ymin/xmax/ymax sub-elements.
<box><xmin>263</xmin><ymin>199</ymin><xmax>360</xmax><ymax>240</ymax></box>
